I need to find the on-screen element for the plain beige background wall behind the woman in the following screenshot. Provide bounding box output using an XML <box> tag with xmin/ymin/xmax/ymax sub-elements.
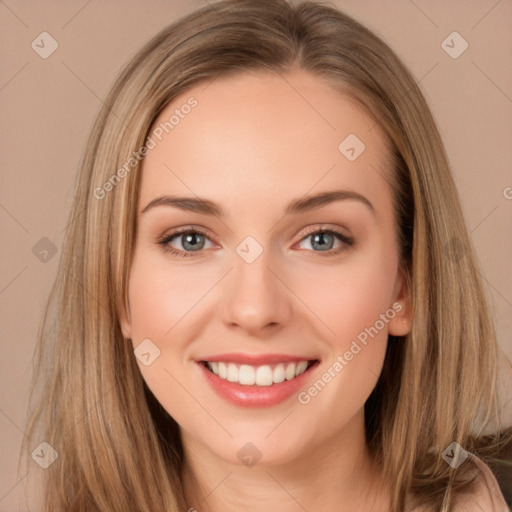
<box><xmin>0</xmin><ymin>0</ymin><xmax>512</xmax><ymax>512</ymax></box>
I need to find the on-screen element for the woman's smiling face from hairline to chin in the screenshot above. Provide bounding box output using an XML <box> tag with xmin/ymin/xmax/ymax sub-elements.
<box><xmin>121</xmin><ymin>70</ymin><xmax>410</xmax><ymax>464</ymax></box>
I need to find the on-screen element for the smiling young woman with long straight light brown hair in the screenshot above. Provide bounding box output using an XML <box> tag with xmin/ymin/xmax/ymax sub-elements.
<box><xmin>23</xmin><ymin>0</ymin><xmax>506</xmax><ymax>512</ymax></box>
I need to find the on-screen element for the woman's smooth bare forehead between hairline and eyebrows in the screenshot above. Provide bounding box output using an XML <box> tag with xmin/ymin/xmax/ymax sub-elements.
<box><xmin>139</xmin><ymin>71</ymin><xmax>389</xmax><ymax>216</ymax></box>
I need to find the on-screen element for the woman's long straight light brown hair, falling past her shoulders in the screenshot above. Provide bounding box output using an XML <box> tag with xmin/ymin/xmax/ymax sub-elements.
<box><xmin>25</xmin><ymin>0</ymin><xmax>510</xmax><ymax>512</ymax></box>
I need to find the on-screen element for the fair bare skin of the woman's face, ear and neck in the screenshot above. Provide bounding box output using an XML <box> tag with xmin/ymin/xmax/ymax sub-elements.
<box><xmin>121</xmin><ymin>70</ymin><xmax>411</xmax><ymax>512</ymax></box>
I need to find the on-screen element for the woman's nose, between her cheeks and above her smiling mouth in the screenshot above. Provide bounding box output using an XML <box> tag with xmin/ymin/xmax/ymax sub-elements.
<box><xmin>222</xmin><ymin>251</ymin><xmax>292</xmax><ymax>337</ymax></box>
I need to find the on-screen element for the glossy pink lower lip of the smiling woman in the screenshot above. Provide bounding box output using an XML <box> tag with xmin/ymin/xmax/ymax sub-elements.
<box><xmin>197</xmin><ymin>361</ymin><xmax>319</xmax><ymax>407</ymax></box>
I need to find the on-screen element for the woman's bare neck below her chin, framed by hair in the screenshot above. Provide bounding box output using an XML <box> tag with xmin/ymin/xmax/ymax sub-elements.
<box><xmin>182</xmin><ymin>414</ymin><xmax>389</xmax><ymax>512</ymax></box>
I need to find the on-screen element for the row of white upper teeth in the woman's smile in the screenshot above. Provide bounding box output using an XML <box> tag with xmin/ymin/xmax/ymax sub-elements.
<box><xmin>207</xmin><ymin>361</ymin><xmax>308</xmax><ymax>386</ymax></box>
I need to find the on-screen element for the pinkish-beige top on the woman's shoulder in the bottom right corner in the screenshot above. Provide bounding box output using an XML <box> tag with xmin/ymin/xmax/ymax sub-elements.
<box><xmin>411</xmin><ymin>453</ymin><xmax>509</xmax><ymax>512</ymax></box>
